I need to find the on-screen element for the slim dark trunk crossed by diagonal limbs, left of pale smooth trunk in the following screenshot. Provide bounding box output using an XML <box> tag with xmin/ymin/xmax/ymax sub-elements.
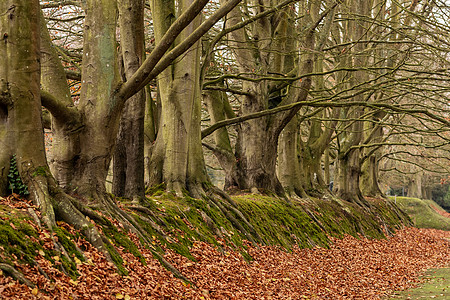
<box><xmin>113</xmin><ymin>0</ymin><xmax>145</xmax><ymax>198</ymax></box>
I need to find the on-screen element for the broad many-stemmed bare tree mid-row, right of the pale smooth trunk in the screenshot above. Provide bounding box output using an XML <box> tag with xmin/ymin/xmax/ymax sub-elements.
<box><xmin>204</xmin><ymin>2</ymin><xmax>337</xmax><ymax>195</ymax></box>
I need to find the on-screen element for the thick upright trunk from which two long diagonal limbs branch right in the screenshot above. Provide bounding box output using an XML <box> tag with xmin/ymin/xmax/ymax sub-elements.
<box><xmin>72</xmin><ymin>0</ymin><xmax>122</xmax><ymax>201</ymax></box>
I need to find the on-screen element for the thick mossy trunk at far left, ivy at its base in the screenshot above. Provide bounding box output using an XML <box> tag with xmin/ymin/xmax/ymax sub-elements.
<box><xmin>0</xmin><ymin>0</ymin><xmax>55</xmax><ymax>226</ymax></box>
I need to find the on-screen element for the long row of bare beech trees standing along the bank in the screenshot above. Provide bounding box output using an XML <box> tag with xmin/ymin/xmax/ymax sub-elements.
<box><xmin>0</xmin><ymin>0</ymin><xmax>450</xmax><ymax>237</ymax></box>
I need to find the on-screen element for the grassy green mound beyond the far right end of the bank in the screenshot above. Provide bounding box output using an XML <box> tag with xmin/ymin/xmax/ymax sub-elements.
<box><xmin>392</xmin><ymin>197</ymin><xmax>450</xmax><ymax>231</ymax></box>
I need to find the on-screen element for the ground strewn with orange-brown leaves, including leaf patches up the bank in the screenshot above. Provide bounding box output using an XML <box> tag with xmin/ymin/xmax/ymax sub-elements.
<box><xmin>0</xmin><ymin>196</ymin><xmax>450</xmax><ymax>299</ymax></box>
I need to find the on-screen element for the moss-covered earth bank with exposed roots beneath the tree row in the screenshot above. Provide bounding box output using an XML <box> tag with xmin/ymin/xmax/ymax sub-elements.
<box><xmin>0</xmin><ymin>192</ymin><xmax>410</xmax><ymax>284</ymax></box>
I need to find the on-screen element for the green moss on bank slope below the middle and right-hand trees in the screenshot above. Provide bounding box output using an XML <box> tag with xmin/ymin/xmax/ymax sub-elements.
<box><xmin>123</xmin><ymin>190</ymin><xmax>407</xmax><ymax>261</ymax></box>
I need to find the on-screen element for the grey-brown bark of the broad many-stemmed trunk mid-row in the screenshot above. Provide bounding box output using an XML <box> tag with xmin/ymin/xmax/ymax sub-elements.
<box><xmin>213</xmin><ymin>1</ymin><xmax>315</xmax><ymax>195</ymax></box>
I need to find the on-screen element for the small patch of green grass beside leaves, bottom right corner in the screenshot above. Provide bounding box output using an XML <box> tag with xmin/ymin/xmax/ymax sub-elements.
<box><xmin>391</xmin><ymin>268</ymin><xmax>450</xmax><ymax>299</ymax></box>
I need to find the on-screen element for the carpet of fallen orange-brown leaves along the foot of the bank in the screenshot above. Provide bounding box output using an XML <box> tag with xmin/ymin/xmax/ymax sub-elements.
<box><xmin>0</xmin><ymin>198</ymin><xmax>450</xmax><ymax>299</ymax></box>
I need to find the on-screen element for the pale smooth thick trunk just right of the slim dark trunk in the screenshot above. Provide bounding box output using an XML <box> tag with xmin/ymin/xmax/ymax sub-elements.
<box><xmin>151</xmin><ymin>1</ymin><xmax>208</xmax><ymax>197</ymax></box>
